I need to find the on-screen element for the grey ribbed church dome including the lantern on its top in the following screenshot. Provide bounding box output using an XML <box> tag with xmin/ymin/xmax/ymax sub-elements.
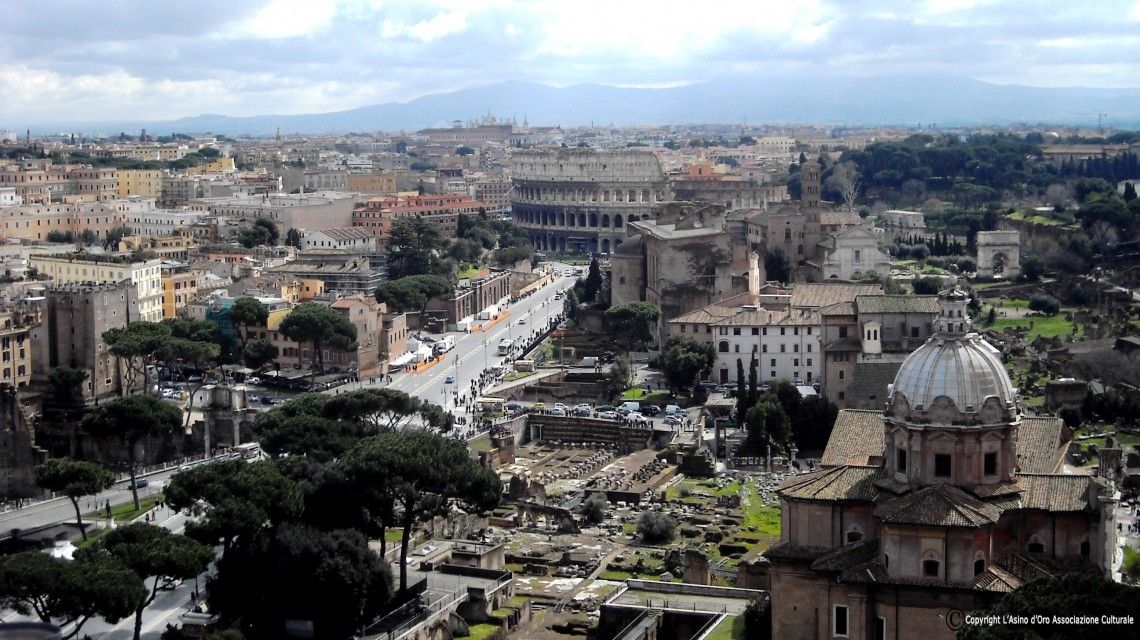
<box><xmin>887</xmin><ymin>289</ymin><xmax>1017</xmax><ymax>422</ymax></box>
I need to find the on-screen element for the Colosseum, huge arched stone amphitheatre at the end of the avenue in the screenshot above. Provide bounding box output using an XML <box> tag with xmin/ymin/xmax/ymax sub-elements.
<box><xmin>511</xmin><ymin>148</ymin><xmax>673</xmax><ymax>253</ymax></box>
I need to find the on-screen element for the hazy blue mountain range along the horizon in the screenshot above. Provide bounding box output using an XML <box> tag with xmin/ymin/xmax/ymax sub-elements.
<box><xmin>32</xmin><ymin>75</ymin><xmax>1140</xmax><ymax>136</ymax></box>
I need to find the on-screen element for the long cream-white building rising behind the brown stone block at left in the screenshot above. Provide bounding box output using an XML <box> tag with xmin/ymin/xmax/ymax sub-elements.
<box><xmin>29</xmin><ymin>254</ymin><xmax>162</xmax><ymax>322</ymax></box>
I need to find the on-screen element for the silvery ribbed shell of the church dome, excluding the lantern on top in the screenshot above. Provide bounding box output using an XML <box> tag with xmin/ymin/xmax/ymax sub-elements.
<box><xmin>889</xmin><ymin>333</ymin><xmax>1016</xmax><ymax>413</ymax></box>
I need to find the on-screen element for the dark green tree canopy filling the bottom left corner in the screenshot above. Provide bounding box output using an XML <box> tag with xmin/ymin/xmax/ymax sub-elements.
<box><xmin>0</xmin><ymin>551</ymin><xmax>146</xmax><ymax>640</ymax></box>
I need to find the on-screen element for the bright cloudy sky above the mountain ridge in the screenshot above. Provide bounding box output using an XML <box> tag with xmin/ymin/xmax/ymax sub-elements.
<box><xmin>0</xmin><ymin>0</ymin><xmax>1140</xmax><ymax>123</ymax></box>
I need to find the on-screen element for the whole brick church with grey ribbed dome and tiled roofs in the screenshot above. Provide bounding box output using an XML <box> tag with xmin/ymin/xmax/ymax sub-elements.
<box><xmin>766</xmin><ymin>290</ymin><xmax>1116</xmax><ymax>640</ymax></box>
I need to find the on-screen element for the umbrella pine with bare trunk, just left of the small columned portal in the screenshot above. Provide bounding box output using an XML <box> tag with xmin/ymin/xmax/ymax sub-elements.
<box><xmin>80</xmin><ymin>395</ymin><xmax>182</xmax><ymax>510</ymax></box>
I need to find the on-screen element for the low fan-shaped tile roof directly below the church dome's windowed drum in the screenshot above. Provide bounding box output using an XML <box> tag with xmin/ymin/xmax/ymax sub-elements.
<box><xmin>874</xmin><ymin>485</ymin><xmax>1001</xmax><ymax>528</ymax></box>
